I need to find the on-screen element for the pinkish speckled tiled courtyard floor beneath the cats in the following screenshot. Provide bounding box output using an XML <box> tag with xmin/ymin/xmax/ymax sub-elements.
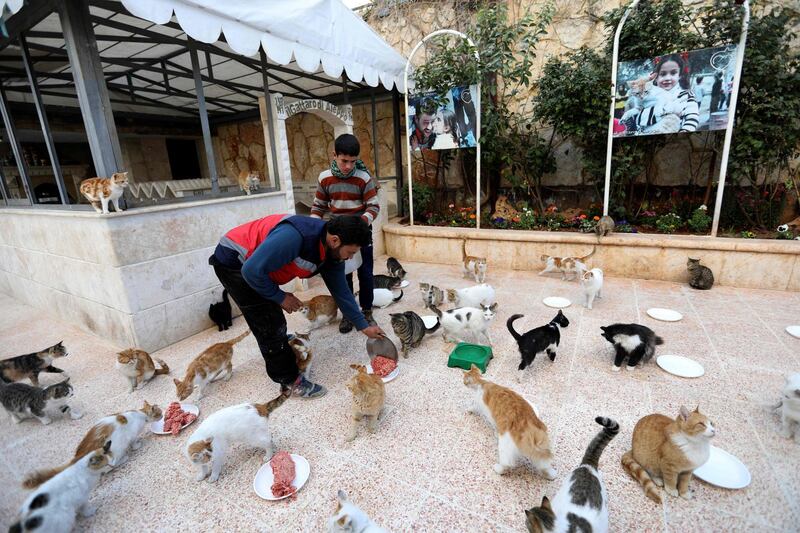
<box><xmin>0</xmin><ymin>258</ymin><xmax>800</xmax><ymax>532</ymax></box>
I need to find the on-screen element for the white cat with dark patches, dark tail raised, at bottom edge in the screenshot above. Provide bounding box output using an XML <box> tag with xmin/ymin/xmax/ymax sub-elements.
<box><xmin>525</xmin><ymin>416</ymin><xmax>619</xmax><ymax>533</ymax></box>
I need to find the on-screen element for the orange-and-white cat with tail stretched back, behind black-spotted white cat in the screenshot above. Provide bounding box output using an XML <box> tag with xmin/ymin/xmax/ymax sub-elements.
<box><xmin>22</xmin><ymin>402</ymin><xmax>162</xmax><ymax>489</ymax></box>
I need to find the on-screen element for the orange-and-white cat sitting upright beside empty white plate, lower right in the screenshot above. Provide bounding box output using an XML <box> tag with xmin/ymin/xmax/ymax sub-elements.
<box><xmin>622</xmin><ymin>406</ymin><xmax>716</xmax><ymax>503</ymax></box>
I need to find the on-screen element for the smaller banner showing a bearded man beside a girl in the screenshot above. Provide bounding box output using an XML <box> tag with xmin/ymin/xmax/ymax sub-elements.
<box><xmin>406</xmin><ymin>85</ymin><xmax>479</xmax><ymax>150</ymax></box>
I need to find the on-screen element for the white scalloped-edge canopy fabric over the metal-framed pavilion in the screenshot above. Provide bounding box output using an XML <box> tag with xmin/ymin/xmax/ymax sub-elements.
<box><xmin>119</xmin><ymin>0</ymin><xmax>406</xmax><ymax>92</ymax></box>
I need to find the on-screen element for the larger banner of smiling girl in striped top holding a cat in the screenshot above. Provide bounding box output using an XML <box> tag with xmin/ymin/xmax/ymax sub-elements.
<box><xmin>614</xmin><ymin>45</ymin><xmax>736</xmax><ymax>137</ymax></box>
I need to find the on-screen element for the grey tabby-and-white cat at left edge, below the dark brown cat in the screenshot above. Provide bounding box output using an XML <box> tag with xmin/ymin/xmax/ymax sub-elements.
<box><xmin>0</xmin><ymin>378</ymin><xmax>83</xmax><ymax>425</ymax></box>
